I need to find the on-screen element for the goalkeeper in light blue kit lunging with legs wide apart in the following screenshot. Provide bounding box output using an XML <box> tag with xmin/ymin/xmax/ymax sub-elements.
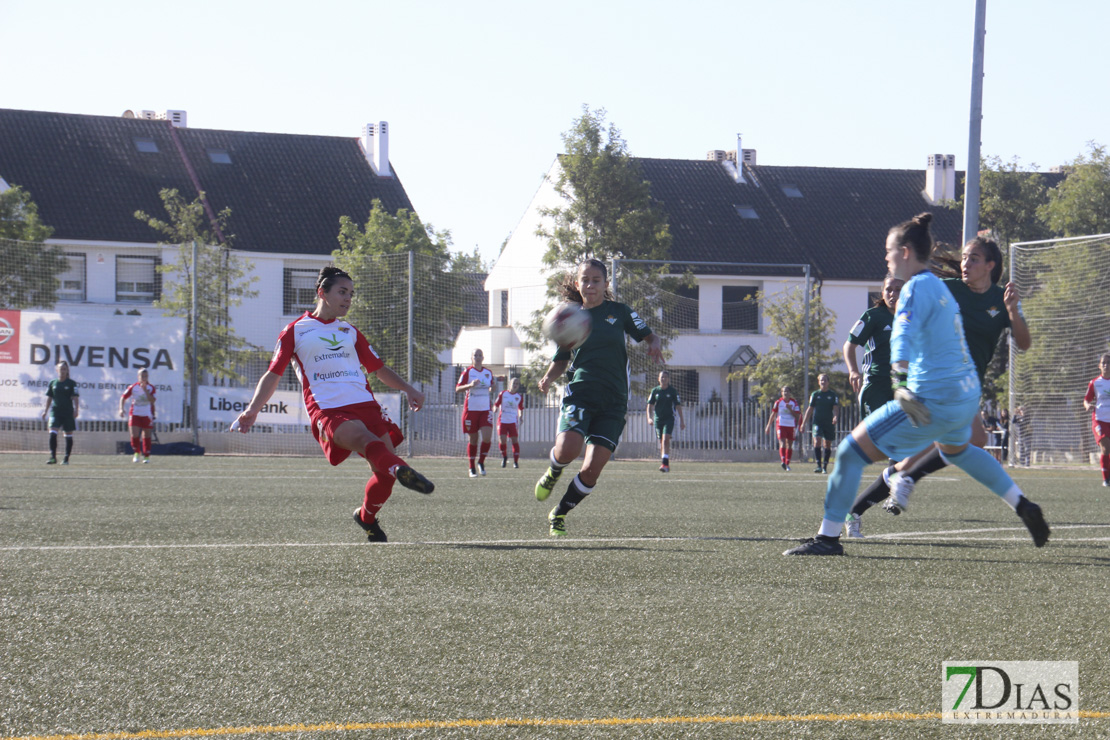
<box><xmin>784</xmin><ymin>213</ymin><xmax>1049</xmax><ymax>555</ymax></box>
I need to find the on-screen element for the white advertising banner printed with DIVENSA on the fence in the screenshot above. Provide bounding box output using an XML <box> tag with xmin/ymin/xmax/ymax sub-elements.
<box><xmin>0</xmin><ymin>311</ymin><xmax>185</xmax><ymax>424</ymax></box>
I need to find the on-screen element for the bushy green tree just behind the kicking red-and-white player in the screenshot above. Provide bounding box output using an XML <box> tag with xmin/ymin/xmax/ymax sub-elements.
<box><xmin>332</xmin><ymin>200</ymin><xmax>463</xmax><ymax>387</ymax></box>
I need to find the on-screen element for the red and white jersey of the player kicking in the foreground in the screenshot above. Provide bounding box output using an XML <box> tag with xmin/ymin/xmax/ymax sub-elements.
<box><xmin>270</xmin><ymin>312</ymin><xmax>384</xmax><ymax>415</ymax></box>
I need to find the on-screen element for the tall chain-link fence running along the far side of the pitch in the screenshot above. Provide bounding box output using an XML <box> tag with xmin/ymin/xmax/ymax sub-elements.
<box><xmin>0</xmin><ymin>242</ymin><xmax>855</xmax><ymax>459</ymax></box>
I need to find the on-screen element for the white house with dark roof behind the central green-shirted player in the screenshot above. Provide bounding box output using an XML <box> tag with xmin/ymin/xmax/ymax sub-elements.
<box><xmin>481</xmin><ymin>140</ymin><xmax>962</xmax><ymax>403</ymax></box>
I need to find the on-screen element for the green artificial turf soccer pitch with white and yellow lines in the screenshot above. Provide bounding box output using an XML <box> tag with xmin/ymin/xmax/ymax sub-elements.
<box><xmin>0</xmin><ymin>455</ymin><xmax>1110</xmax><ymax>740</ymax></box>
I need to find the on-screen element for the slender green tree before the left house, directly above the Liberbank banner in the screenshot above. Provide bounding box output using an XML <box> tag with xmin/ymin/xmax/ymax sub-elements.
<box><xmin>134</xmin><ymin>189</ymin><xmax>258</xmax><ymax>381</ymax></box>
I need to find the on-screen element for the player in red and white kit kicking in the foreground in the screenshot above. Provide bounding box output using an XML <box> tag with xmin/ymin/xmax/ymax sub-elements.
<box><xmin>232</xmin><ymin>265</ymin><xmax>435</xmax><ymax>543</ymax></box>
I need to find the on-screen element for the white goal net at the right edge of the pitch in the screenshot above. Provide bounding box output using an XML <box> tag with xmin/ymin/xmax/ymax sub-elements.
<box><xmin>1009</xmin><ymin>234</ymin><xmax>1110</xmax><ymax>465</ymax></box>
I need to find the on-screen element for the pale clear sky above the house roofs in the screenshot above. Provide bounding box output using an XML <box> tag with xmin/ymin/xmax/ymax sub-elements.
<box><xmin>0</xmin><ymin>0</ymin><xmax>1110</xmax><ymax>260</ymax></box>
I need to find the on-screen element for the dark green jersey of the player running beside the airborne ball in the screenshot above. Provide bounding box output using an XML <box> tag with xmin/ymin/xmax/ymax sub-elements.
<box><xmin>552</xmin><ymin>301</ymin><xmax>652</xmax><ymax>405</ymax></box>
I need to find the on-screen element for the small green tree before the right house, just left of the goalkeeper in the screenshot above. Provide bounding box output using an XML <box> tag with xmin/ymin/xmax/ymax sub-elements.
<box><xmin>728</xmin><ymin>286</ymin><xmax>834</xmax><ymax>404</ymax></box>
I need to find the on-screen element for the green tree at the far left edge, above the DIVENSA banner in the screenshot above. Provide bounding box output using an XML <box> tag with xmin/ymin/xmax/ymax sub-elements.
<box><xmin>0</xmin><ymin>185</ymin><xmax>69</xmax><ymax>308</ymax></box>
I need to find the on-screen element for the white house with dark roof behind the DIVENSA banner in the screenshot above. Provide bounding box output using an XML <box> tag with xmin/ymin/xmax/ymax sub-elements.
<box><xmin>0</xmin><ymin>109</ymin><xmax>413</xmax><ymax>355</ymax></box>
